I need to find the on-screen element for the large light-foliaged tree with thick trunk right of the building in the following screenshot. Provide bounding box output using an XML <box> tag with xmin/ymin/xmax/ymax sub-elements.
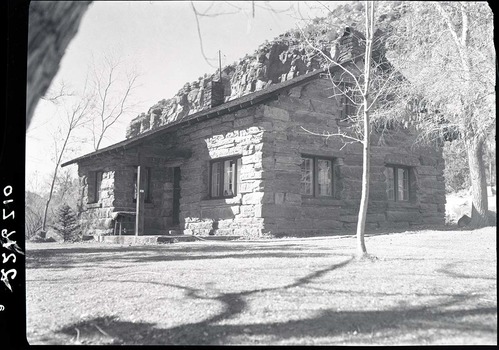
<box><xmin>386</xmin><ymin>2</ymin><xmax>496</xmax><ymax>227</ymax></box>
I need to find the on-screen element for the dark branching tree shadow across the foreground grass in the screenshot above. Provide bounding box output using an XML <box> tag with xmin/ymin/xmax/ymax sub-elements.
<box><xmin>52</xmin><ymin>258</ymin><xmax>497</xmax><ymax>345</ymax></box>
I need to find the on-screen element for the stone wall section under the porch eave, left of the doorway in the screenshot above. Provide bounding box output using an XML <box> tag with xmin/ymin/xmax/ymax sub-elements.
<box><xmin>78</xmin><ymin>150</ymin><xmax>175</xmax><ymax>235</ymax></box>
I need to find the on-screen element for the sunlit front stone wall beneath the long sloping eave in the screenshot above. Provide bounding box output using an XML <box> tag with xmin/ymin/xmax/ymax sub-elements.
<box><xmin>79</xmin><ymin>107</ymin><xmax>270</xmax><ymax>237</ymax></box>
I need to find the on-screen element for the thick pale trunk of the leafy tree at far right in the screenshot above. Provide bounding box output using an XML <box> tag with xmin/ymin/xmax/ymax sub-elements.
<box><xmin>466</xmin><ymin>138</ymin><xmax>489</xmax><ymax>228</ymax></box>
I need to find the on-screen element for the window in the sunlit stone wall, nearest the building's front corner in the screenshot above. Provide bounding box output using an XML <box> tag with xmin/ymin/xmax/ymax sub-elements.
<box><xmin>210</xmin><ymin>157</ymin><xmax>242</xmax><ymax>198</ymax></box>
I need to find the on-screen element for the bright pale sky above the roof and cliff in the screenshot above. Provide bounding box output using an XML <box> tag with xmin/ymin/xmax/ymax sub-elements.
<box><xmin>26</xmin><ymin>1</ymin><xmax>344</xmax><ymax>187</ymax></box>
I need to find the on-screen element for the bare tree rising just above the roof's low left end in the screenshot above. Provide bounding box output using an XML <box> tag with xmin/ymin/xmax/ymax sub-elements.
<box><xmin>91</xmin><ymin>55</ymin><xmax>139</xmax><ymax>150</ymax></box>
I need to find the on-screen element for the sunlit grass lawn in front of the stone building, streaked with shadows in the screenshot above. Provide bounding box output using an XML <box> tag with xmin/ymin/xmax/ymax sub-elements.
<box><xmin>26</xmin><ymin>227</ymin><xmax>497</xmax><ymax>345</ymax></box>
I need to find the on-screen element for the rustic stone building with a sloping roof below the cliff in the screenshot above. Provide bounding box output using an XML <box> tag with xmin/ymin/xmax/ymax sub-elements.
<box><xmin>63</xmin><ymin>28</ymin><xmax>445</xmax><ymax>237</ymax></box>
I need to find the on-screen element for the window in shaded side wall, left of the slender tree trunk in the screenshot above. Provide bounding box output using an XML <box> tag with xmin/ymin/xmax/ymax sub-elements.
<box><xmin>300</xmin><ymin>156</ymin><xmax>333</xmax><ymax>197</ymax></box>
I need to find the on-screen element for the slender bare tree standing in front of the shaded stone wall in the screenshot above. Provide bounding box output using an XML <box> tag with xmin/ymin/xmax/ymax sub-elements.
<box><xmin>302</xmin><ymin>1</ymin><xmax>401</xmax><ymax>258</ymax></box>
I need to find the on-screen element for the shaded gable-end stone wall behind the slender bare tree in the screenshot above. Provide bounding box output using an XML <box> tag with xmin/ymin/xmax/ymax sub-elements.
<box><xmin>256</xmin><ymin>80</ymin><xmax>445</xmax><ymax>235</ymax></box>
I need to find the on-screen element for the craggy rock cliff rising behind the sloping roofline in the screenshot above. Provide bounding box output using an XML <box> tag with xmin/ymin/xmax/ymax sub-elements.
<box><xmin>126</xmin><ymin>33</ymin><xmax>330</xmax><ymax>138</ymax></box>
